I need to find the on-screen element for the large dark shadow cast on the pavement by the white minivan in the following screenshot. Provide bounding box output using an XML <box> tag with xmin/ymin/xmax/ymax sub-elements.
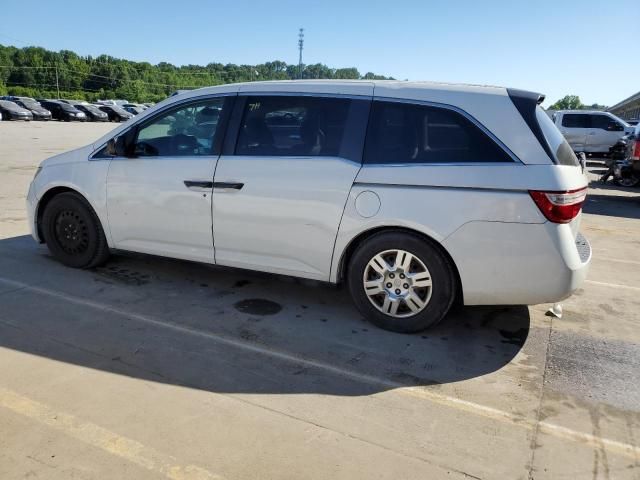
<box><xmin>0</xmin><ymin>236</ymin><xmax>530</xmax><ymax>395</ymax></box>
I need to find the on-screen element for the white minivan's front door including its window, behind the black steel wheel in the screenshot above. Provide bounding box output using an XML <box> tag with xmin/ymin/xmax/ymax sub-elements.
<box><xmin>107</xmin><ymin>96</ymin><xmax>234</xmax><ymax>263</ymax></box>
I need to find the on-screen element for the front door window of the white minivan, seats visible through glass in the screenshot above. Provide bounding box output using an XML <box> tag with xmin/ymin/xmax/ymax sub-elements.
<box><xmin>133</xmin><ymin>97</ymin><xmax>224</xmax><ymax>157</ymax></box>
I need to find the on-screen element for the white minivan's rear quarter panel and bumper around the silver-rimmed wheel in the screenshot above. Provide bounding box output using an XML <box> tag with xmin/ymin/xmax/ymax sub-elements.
<box><xmin>331</xmin><ymin>163</ymin><xmax>586</xmax><ymax>305</ymax></box>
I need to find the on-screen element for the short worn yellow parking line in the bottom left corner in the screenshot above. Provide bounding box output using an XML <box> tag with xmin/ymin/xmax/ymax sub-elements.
<box><xmin>0</xmin><ymin>387</ymin><xmax>222</xmax><ymax>480</ymax></box>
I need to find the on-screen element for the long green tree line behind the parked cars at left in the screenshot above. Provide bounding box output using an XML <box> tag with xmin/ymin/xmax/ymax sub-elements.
<box><xmin>0</xmin><ymin>45</ymin><xmax>392</xmax><ymax>102</ymax></box>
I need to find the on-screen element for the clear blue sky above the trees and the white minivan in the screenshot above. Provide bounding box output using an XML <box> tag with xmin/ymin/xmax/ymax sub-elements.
<box><xmin>0</xmin><ymin>0</ymin><xmax>640</xmax><ymax>106</ymax></box>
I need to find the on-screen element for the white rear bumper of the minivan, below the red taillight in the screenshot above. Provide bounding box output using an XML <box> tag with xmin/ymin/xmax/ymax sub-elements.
<box><xmin>443</xmin><ymin>222</ymin><xmax>592</xmax><ymax>305</ymax></box>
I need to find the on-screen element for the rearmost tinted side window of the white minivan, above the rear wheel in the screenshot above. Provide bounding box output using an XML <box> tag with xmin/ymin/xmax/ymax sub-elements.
<box><xmin>364</xmin><ymin>101</ymin><xmax>513</xmax><ymax>164</ymax></box>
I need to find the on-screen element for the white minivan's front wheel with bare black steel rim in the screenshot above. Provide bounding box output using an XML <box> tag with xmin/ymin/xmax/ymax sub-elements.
<box><xmin>42</xmin><ymin>192</ymin><xmax>109</xmax><ymax>268</ymax></box>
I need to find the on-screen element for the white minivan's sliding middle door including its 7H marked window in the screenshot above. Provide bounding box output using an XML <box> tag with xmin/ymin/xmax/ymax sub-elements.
<box><xmin>213</xmin><ymin>95</ymin><xmax>370</xmax><ymax>280</ymax></box>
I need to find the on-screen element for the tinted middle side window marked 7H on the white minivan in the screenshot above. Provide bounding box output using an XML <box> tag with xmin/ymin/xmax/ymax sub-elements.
<box><xmin>235</xmin><ymin>96</ymin><xmax>351</xmax><ymax>156</ymax></box>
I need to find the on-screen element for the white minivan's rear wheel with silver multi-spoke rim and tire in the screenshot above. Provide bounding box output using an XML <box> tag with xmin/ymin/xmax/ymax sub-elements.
<box><xmin>347</xmin><ymin>232</ymin><xmax>456</xmax><ymax>333</ymax></box>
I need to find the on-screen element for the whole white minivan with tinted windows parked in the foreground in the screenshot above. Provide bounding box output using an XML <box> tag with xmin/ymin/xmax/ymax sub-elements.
<box><xmin>27</xmin><ymin>81</ymin><xmax>591</xmax><ymax>332</ymax></box>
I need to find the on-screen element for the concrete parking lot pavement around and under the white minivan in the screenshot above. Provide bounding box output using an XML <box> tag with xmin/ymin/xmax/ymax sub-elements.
<box><xmin>0</xmin><ymin>122</ymin><xmax>640</xmax><ymax>480</ymax></box>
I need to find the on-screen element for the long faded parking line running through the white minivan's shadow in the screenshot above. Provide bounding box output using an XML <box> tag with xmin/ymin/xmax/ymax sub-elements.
<box><xmin>0</xmin><ymin>277</ymin><xmax>640</xmax><ymax>460</ymax></box>
